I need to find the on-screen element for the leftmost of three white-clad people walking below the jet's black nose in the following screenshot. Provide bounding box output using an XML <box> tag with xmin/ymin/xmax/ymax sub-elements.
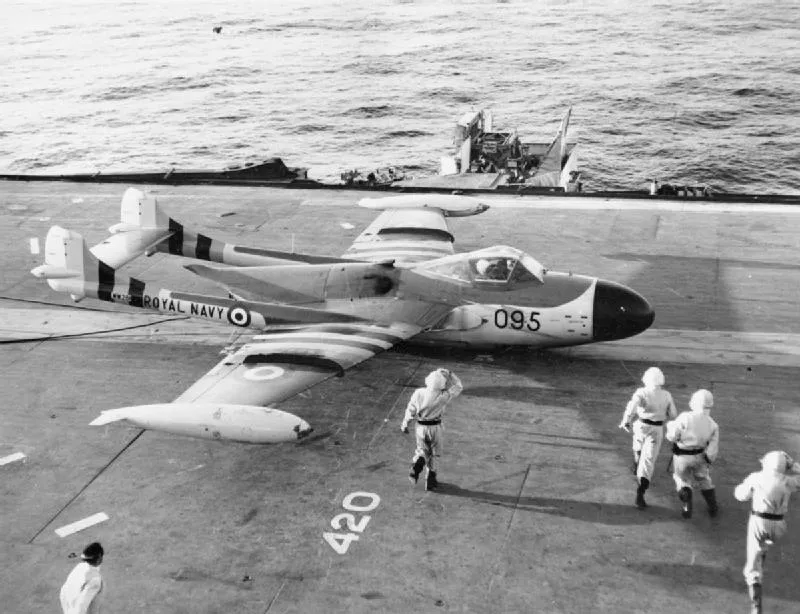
<box><xmin>619</xmin><ymin>367</ymin><xmax>678</xmax><ymax>509</ymax></box>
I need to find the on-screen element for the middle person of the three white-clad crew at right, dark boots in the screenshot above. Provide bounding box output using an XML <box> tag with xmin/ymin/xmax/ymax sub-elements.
<box><xmin>667</xmin><ymin>389</ymin><xmax>719</xmax><ymax>518</ymax></box>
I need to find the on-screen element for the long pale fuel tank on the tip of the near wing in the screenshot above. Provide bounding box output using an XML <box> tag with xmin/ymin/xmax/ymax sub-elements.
<box><xmin>90</xmin><ymin>403</ymin><xmax>313</xmax><ymax>444</ymax></box>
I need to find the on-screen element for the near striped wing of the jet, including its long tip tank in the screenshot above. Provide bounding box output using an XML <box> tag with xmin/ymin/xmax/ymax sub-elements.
<box><xmin>91</xmin><ymin>323</ymin><xmax>423</xmax><ymax>444</ymax></box>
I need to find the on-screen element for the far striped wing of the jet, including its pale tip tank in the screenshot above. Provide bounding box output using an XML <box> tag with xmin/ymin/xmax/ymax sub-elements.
<box><xmin>343</xmin><ymin>194</ymin><xmax>489</xmax><ymax>263</ymax></box>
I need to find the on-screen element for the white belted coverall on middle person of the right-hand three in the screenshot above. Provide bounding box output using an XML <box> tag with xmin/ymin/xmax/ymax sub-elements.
<box><xmin>667</xmin><ymin>397</ymin><xmax>719</xmax><ymax>491</ymax></box>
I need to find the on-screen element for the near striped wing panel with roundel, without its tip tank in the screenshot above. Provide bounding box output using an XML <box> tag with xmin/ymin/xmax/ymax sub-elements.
<box><xmin>174</xmin><ymin>323</ymin><xmax>422</xmax><ymax>406</ymax></box>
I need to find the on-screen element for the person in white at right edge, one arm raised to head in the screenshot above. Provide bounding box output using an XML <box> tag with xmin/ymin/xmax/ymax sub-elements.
<box><xmin>733</xmin><ymin>450</ymin><xmax>800</xmax><ymax>614</ymax></box>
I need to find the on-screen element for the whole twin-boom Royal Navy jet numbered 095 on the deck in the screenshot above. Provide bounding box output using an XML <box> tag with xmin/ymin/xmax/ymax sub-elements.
<box><xmin>31</xmin><ymin>188</ymin><xmax>654</xmax><ymax>443</ymax></box>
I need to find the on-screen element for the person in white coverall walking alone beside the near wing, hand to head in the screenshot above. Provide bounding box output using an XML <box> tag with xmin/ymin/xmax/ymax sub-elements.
<box><xmin>400</xmin><ymin>369</ymin><xmax>464</xmax><ymax>490</ymax></box>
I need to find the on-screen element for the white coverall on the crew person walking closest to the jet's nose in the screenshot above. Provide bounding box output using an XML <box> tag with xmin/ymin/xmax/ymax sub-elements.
<box><xmin>620</xmin><ymin>386</ymin><xmax>678</xmax><ymax>480</ymax></box>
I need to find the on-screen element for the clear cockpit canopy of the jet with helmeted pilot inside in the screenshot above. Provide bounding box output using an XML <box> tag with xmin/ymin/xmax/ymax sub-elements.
<box><xmin>418</xmin><ymin>245</ymin><xmax>546</xmax><ymax>287</ymax></box>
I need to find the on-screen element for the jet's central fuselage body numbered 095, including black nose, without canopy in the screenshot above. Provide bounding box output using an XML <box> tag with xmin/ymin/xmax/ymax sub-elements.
<box><xmin>187</xmin><ymin>262</ymin><xmax>653</xmax><ymax>347</ymax></box>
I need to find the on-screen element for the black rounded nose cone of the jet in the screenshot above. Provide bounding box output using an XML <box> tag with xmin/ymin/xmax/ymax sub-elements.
<box><xmin>592</xmin><ymin>279</ymin><xmax>656</xmax><ymax>341</ymax></box>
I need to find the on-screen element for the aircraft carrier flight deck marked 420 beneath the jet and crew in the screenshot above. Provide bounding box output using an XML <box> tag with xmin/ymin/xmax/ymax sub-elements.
<box><xmin>0</xmin><ymin>182</ymin><xmax>800</xmax><ymax>614</ymax></box>
